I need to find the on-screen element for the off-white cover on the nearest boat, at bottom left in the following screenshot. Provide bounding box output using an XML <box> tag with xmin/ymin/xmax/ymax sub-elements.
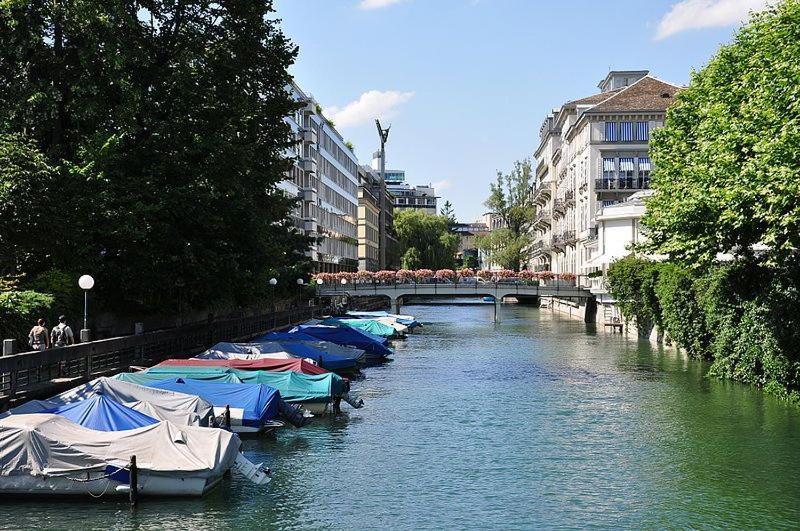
<box><xmin>0</xmin><ymin>413</ymin><xmax>241</xmax><ymax>478</ymax></box>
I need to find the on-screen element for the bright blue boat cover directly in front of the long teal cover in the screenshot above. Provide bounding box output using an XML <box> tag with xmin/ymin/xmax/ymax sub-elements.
<box><xmin>146</xmin><ymin>378</ymin><xmax>281</xmax><ymax>428</ymax></box>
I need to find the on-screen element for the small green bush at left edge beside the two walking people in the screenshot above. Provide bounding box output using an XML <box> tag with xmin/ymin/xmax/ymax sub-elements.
<box><xmin>0</xmin><ymin>291</ymin><xmax>54</xmax><ymax>344</ymax></box>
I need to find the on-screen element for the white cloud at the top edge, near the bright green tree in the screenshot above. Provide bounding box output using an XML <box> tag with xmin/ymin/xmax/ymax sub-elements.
<box><xmin>656</xmin><ymin>0</ymin><xmax>768</xmax><ymax>39</ymax></box>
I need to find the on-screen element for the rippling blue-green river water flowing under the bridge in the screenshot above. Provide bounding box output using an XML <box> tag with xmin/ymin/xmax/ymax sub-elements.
<box><xmin>0</xmin><ymin>305</ymin><xmax>800</xmax><ymax>529</ymax></box>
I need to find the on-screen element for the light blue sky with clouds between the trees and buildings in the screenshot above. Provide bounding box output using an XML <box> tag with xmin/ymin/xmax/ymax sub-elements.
<box><xmin>275</xmin><ymin>0</ymin><xmax>767</xmax><ymax>222</ymax></box>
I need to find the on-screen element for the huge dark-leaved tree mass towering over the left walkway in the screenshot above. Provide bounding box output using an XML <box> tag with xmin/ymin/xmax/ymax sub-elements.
<box><xmin>0</xmin><ymin>0</ymin><xmax>308</xmax><ymax>309</ymax></box>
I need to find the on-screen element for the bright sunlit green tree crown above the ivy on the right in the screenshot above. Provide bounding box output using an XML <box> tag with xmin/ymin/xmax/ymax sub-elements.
<box><xmin>643</xmin><ymin>0</ymin><xmax>800</xmax><ymax>269</ymax></box>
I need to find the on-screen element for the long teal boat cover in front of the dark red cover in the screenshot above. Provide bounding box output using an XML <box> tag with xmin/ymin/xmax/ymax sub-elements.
<box><xmin>114</xmin><ymin>365</ymin><xmax>350</xmax><ymax>402</ymax></box>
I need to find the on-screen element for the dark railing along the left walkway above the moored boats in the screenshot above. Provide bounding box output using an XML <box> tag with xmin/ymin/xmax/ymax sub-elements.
<box><xmin>0</xmin><ymin>306</ymin><xmax>323</xmax><ymax>409</ymax></box>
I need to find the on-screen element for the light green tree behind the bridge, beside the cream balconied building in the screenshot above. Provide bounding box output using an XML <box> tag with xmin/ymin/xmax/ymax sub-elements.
<box><xmin>478</xmin><ymin>159</ymin><xmax>536</xmax><ymax>271</ymax></box>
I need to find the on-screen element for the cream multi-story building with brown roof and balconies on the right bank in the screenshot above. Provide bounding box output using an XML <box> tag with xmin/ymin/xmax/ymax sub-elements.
<box><xmin>531</xmin><ymin>70</ymin><xmax>680</xmax><ymax>282</ymax></box>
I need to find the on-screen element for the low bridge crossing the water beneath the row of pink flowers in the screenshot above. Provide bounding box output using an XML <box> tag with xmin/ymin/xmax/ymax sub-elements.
<box><xmin>316</xmin><ymin>280</ymin><xmax>594</xmax><ymax>318</ymax></box>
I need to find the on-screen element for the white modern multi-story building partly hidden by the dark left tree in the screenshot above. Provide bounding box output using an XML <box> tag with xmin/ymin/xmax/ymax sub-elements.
<box><xmin>281</xmin><ymin>83</ymin><xmax>359</xmax><ymax>272</ymax></box>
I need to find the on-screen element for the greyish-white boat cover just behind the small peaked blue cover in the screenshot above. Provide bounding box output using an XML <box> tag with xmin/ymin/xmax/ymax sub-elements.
<box><xmin>10</xmin><ymin>377</ymin><xmax>214</xmax><ymax>426</ymax></box>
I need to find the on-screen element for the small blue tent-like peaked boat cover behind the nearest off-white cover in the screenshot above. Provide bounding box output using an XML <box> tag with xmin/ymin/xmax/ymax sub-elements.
<box><xmin>46</xmin><ymin>395</ymin><xmax>159</xmax><ymax>431</ymax></box>
